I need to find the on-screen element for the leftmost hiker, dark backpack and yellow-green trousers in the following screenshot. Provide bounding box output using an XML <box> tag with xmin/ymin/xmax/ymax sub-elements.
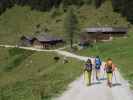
<box><xmin>84</xmin><ymin>59</ymin><xmax>92</xmax><ymax>85</ymax></box>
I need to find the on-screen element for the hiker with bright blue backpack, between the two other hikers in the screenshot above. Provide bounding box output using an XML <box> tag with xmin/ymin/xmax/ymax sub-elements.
<box><xmin>95</xmin><ymin>56</ymin><xmax>102</xmax><ymax>80</ymax></box>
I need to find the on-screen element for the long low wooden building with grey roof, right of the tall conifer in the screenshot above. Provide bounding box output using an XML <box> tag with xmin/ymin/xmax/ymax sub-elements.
<box><xmin>81</xmin><ymin>27</ymin><xmax>128</xmax><ymax>42</ymax></box>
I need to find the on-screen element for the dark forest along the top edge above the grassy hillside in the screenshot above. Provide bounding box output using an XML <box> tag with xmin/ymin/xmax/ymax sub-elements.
<box><xmin>0</xmin><ymin>0</ymin><xmax>133</xmax><ymax>23</ymax></box>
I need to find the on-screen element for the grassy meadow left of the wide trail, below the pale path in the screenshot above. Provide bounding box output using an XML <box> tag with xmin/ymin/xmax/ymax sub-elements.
<box><xmin>0</xmin><ymin>48</ymin><xmax>83</xmax><ymax>100</ymax></box>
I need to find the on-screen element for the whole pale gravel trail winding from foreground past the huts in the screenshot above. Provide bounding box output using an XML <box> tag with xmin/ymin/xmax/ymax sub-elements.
<box><xmin>0</xmin><ymin>45</ymin><xmax>133</xmax><ymax>100</ymax></box>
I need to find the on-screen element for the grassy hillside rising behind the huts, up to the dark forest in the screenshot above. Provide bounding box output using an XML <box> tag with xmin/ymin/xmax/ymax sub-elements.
<box><xmin>0</xmin><ymin>1</ymin><xmax>131</xmax><ymax>44</ymax></box>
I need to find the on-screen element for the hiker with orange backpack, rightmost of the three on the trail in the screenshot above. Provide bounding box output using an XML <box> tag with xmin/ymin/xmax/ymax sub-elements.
<box><xmin>105</xmin><ymin>58</ymin><xmax>116</xmax><ymax>87</ymax></box>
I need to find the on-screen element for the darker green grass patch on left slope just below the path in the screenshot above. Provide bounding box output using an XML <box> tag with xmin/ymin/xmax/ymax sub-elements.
<box><xmin>0</xmin><ymin>48</ymin><xmax>33</xmax><ymax>72</ymax></box>
